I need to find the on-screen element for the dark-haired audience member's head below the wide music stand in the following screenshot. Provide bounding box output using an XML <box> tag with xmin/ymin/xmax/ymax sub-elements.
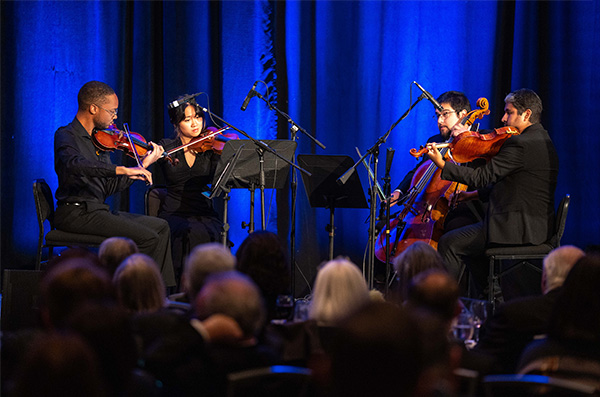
<box><xmin>236</xmin><ymin>230</ymin><xmax>291</xmax><ymax>321</ymax></box>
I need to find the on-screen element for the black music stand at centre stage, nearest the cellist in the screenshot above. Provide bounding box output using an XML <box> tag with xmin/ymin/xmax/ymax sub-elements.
<box><xmin>297</xmin><ymin>154</ymin><xmax>369</xmax><ymax>260</ymax></box>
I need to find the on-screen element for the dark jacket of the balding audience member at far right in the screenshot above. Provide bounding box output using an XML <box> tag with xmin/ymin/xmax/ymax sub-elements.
<box><xmin>475</xmin><ymin>287</ymin><xmax>560</xmax><ymax>373</ymax></box>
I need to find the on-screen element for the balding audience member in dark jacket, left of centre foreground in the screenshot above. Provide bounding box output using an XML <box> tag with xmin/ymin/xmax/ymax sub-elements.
<box><xmin>145</xmin><ymin>271</ymin><xmax>270</xmax><ymax>396</ymax></box>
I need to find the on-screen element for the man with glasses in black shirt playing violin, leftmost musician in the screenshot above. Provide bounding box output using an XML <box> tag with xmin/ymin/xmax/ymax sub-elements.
<box><xmin>54</xmin><ymin>81</ymin><xmax>175</xmax><ymax>287</ymax></box>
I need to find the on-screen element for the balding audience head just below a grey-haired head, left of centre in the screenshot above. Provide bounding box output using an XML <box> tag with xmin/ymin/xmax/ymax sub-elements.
<box><xmin>194</xmin><ymin>270</ymin><xmax>266</xmax><ymax>337</ymax></box>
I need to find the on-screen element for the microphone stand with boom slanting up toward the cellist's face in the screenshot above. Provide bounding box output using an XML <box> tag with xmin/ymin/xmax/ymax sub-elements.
<box><xmin>337</xmin><ymin>94</ymin><xmax>426</xmax><ymax>289</ymax></box>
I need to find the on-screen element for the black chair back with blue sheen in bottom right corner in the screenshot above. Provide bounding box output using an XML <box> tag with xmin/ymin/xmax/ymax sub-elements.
<box><xmin>482</xmin><ymin>374</ymin><xmax>600</xmax><ymax>397</ymax></box>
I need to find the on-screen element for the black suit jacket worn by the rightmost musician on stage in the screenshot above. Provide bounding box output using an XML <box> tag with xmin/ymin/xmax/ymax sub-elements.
<box><xmin>441</xmin><ymin>124</ymin><xmax>558</xmax><ymax>245</ymax></box>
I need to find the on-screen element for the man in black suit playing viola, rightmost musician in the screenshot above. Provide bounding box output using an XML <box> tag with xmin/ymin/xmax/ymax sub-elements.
<box><xmin>427</xmin><ymin>89</ymin><xmax>558</xmax><ymax>298</ymax></box>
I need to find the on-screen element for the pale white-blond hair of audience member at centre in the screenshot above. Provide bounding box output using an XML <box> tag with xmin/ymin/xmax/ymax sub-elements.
<box><xmin>309</xmin><ymin>258</ymin><xmax>370</xmax><ymax>326</ymax></box>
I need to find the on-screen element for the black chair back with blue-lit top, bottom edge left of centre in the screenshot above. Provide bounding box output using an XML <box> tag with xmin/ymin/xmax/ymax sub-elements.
<box><xmin>227</xmin><ymin>365</ymin><xmax>316</xmax><ymax>397</ymax></box>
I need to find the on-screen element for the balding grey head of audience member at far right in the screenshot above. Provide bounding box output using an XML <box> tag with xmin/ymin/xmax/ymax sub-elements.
<box><xmin>542</xmin><ymin>245</ymin><xmax>585</xmax><ymax>293</ymax></box>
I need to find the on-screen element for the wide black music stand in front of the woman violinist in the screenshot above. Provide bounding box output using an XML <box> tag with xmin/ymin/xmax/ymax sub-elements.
<box><xmin>215</xmin><ymin>139</ymin><xmax>297</xmax><ymax>233</ymax></box>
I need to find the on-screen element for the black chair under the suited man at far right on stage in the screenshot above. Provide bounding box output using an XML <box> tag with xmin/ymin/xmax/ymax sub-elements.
<box><xmin>485</xmin><ymin>194</ymin><xmax>571</xmax><ymax>310</ymax></box>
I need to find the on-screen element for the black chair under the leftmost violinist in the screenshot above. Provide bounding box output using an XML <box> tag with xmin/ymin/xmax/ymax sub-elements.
<box><xmin>33</xmin><ymin>179</ymin><xmax>107</xmax><ymax>270</ymax></box>
